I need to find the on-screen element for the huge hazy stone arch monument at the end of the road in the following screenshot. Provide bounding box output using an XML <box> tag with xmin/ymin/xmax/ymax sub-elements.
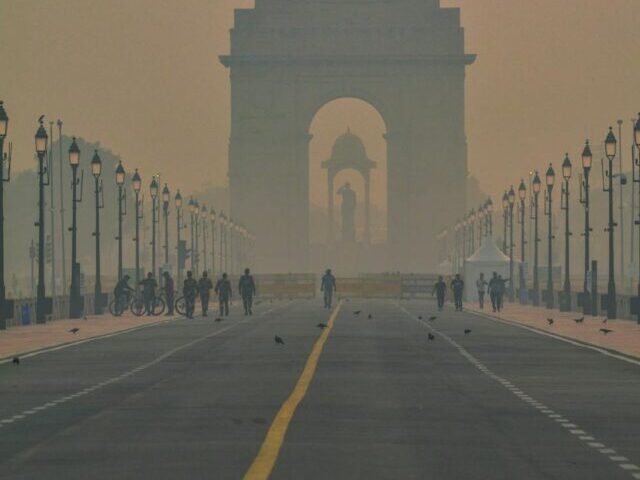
<box><xmin>220</xmin><ymin>0</ymin><xmax>475</xmax><ymax>272</ymax></box>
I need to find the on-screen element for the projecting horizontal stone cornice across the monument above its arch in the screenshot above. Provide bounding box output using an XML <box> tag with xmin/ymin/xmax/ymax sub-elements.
<box><xmin>219</xmin><ymin>54</ymin><xmax>476</xmax><ymax>68</ymax></box>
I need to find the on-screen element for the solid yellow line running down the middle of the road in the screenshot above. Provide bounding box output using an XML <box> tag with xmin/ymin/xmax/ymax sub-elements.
<box><xmin>244</xmin><ymin>301</ymin><xmax>342</xmax><ymax>480</ymax></box>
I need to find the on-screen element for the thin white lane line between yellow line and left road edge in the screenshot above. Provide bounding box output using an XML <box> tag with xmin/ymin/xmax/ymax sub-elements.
<box><xmin>0</xmin><ymin>302</ymin><xmax>291</xmax><ymax>434</ymax></box>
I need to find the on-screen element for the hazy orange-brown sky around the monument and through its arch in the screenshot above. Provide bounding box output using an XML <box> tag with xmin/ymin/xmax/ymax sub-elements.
<box><xmin>0</xmin><ymin>0</ymin><xmax>640</xmax><ymax>210</ymax></box>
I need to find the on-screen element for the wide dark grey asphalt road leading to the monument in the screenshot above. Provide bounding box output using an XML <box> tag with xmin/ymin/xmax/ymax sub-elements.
<box><xmin>0</xmin><ymin>300</ymin><xmax>640</xmax><ymax>480</ymax></box>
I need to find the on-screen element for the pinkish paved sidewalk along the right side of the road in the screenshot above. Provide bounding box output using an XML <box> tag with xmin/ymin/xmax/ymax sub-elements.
<box><xmin>465</xmin><ymin>303</ymin><xmax>640</xmax><ymax>358</ymax></box>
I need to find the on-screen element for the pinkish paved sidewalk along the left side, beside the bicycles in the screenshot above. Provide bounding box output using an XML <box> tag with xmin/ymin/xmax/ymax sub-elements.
<box><xmin>0</xmin><ymin>313</ymin><xmax>176</xmax><ymax>360</ymax></box>
